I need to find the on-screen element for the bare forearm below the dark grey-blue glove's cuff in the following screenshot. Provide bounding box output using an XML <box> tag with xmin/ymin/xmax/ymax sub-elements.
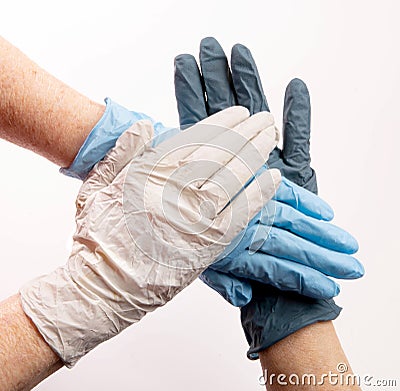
<box><xmin>260</xmin><ymin>322</ymin><xmax>361</xmax><ymax>391</ymax></box>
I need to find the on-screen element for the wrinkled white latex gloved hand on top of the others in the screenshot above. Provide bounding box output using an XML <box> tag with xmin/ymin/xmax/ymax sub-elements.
<box><xmin>20</xmin><ymin>107</ymin><xmax>280</xmax><ymax>366</ymax></box>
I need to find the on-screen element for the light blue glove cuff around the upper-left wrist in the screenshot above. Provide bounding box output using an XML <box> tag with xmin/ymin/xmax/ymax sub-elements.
<box><xmin>60</xmin><ymin>98</ymin><xmax>179</xmax><ymax>180</ymax></box>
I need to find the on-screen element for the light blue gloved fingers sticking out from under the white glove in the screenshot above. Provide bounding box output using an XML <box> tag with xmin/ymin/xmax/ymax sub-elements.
<box><xmin>200</xmin><ymin>178</ymin><xmax>364</xmax><ymax>306</ymax></box>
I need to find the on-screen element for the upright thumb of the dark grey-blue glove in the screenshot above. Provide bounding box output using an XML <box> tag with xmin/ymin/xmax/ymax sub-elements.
<box><xmin>282</xmin><ymin>79</ymin><xmax>312</xmax><ymax>168</ymax></box>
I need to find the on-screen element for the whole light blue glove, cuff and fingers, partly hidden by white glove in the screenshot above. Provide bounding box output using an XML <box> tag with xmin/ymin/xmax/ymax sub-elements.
<box><xmin>61</xmin><ymin>98</ymin><xmax>363</xmax><ymax>306</ymax></box>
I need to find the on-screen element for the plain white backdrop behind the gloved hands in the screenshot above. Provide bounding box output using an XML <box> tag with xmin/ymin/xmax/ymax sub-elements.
<box><xmin>0</xmin><ymin>0</ymin><xmax>400</xmax><ymax>391</ymax></box>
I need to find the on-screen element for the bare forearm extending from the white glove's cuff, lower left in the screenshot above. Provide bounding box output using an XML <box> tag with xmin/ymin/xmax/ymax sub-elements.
<box><xmin>0</xmin><ymin>295</ymin><xmax>62</xmax><ymax>391</ymax></box>
